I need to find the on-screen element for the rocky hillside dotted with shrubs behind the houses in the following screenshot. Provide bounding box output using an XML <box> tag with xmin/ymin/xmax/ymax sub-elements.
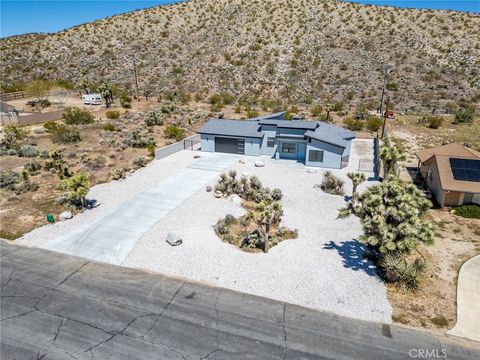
<box><xmin>0</xmin><ymin>0</ymin><xmax>480</xmax><ymax>111</ymax></box>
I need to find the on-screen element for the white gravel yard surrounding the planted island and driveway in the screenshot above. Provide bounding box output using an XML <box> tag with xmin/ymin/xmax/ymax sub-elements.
<box><xmin>18</xmin><ymin>140</ymin><xmax>392</xmax><ymax>322</ymax></box>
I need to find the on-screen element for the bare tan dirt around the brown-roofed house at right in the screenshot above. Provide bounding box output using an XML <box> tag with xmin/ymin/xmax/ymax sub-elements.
<box><xmin>388</xmin><ymin>116</ymin><xmax>480</xmax><ymax>332</ymax></box>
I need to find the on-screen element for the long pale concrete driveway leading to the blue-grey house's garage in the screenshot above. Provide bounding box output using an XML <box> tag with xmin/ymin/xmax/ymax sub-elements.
<box><xmin>41</xmin><ymin>154</ymin><xmax>237</xmax><ymax>265</ymax></box>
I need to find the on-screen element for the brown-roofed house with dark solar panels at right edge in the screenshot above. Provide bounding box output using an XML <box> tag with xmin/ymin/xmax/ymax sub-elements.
<box><xmin>415</xmin><ymin>143</ymin><xmax>480</xmax><ymax>206</ymax></box>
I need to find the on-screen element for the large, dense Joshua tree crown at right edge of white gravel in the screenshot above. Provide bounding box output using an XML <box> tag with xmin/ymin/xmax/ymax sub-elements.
<box><xmin>338</xmin><ymin>175</ymin><xmax>433</xmax><ymax>256</ymax></box>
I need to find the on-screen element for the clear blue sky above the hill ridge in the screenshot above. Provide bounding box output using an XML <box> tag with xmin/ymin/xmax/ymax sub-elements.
<box><xmin>0</xmin><ymin>0</ymin><xmax>480</xmax><ymax>37</ymax></box>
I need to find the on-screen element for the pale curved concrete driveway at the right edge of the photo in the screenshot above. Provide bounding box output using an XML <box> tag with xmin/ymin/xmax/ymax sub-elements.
<box><xmin>447</xmin><ymin>255</ymin><xmax>480</xmax><ymax>342</ymax></box>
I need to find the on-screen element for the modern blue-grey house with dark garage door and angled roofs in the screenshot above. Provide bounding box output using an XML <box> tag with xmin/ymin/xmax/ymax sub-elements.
<box><xmin>198</xmin><ymin>113</ymin><xmax>355</xmax><ymax>169</ymax></box>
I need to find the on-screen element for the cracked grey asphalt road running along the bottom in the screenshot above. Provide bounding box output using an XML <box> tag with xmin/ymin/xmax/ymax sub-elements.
<box><xmin>0</xmin><ymin>241</ymin><xmax>480</xmax><ymax>360</ymax></box>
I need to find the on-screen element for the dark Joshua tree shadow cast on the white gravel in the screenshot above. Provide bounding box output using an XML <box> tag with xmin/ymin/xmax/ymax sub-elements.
<box><xmin>323</xmin><ymin>239</ymin><xmax>378</xmax><ymax>276</ymax></box>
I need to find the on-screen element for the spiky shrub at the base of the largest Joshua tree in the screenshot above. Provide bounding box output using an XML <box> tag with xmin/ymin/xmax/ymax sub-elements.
<box><xmin>379</xmin><ymin>253</ymin><xmax>426</xmax><ymax>291</ymax></box>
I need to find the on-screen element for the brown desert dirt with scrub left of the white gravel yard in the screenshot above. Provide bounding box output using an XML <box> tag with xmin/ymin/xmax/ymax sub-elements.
<box><xmin>0</xmin><ymin>95</ymin><xmax>207</xmax><ymax>239</ymax></box>
